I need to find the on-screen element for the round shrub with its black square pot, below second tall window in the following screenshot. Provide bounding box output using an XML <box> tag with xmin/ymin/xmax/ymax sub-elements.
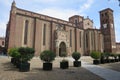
<box><xmin>40</xmin><ymin>50</ymin><xmax>56</xmax><ymax>70</ymax></box>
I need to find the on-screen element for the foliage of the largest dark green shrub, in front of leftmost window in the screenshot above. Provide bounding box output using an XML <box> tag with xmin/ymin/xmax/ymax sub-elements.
<box><xmin>18</xmin><ymin>47</ymin><xmax>35</xmax><ymax>62</ymax></box>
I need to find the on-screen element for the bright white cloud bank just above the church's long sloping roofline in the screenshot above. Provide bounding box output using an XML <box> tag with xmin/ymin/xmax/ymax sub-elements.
<box><xmin>38</xmin><ymin>8</ymin><xmax>83</xmax><ymax>21</ymax></box>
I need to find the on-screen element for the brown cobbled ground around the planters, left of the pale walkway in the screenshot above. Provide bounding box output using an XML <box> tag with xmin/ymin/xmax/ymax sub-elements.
<box><xmin>0</xmin><ymin>56</ymin><xmax>104</xmax><ymax>80</ymax></box>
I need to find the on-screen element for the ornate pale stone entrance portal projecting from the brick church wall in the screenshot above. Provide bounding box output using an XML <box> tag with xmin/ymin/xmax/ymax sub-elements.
<box><xmin>55</xmin><ymin>24</ymin><xmax>69</xmax><ymax>57</ymax></box>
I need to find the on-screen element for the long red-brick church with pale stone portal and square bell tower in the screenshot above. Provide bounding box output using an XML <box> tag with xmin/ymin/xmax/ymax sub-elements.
<box><xmin>5</xmin><ymin>1</ymin><xmax>116</xmax><ymax>56</ymax></box>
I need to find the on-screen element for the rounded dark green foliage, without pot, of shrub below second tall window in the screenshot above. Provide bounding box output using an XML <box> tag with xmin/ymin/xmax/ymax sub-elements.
<box><xmin>40</xmin><ymin>50</ymin><xmax>56</xmax><ymax>62</ymax></box>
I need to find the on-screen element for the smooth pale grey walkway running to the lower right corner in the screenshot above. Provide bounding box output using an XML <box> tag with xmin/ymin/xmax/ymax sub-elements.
<box><xmin>83</xmin><ymin>62</ymin><xmax>120</xmax><ymax>80</ymax></box>
